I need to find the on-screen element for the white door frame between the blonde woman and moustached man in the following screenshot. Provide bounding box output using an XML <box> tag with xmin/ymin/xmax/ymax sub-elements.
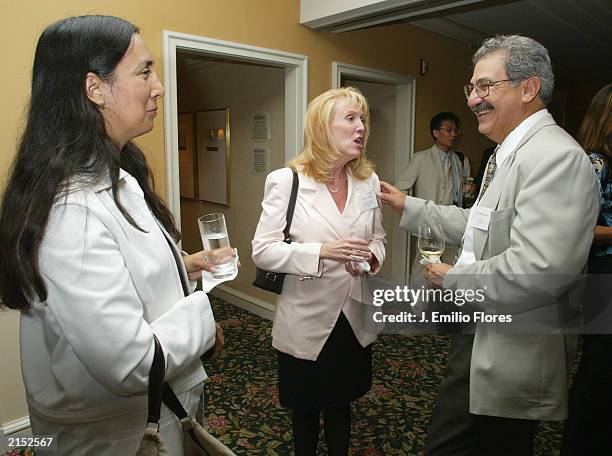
<box><xmin>332</xmin><ymin>62</ymin><xmax>416</xmax><ymax>286</ymax></box>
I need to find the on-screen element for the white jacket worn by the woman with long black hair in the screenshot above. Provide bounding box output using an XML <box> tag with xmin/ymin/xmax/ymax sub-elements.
<box><xmin>21</xmin><ymin>170</ymin><xmax>215</xmax><ymax>454</ymax></box>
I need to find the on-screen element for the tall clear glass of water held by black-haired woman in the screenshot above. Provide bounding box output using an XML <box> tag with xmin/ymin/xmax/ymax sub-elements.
<box><xmin>198</xmin><ymin>213</ymin><xmax>235</xmax><ymax>279</ymax></box>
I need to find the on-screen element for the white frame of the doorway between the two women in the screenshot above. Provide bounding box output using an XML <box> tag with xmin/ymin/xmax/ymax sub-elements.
<box><xmin>163</xmin><ymin>30</ymin><xmax>308</xmax><ymax>230</ymax></box>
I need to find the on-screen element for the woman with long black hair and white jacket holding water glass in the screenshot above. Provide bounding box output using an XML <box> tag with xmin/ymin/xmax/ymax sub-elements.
<box><xmin>0</xmin><ymin>16</ymin><xmax>227</xmax><ymax>456</ymax></box>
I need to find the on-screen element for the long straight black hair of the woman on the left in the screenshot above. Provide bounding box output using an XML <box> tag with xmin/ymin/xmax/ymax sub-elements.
<box><xmin>0</xmin><ymin>16</ymin><xmax>180</xmax><ymax>309</ymax></box>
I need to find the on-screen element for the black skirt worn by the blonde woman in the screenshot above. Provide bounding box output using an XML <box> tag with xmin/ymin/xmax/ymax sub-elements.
<box><xmin>277</xmin><ymin>312</ymin><xmax>372</xmax><ymax>411</ymax></box>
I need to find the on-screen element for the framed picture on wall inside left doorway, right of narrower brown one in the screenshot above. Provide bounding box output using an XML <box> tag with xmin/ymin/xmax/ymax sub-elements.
<box><xmin>195</xmin><ymin>108</ymin><xmax>231</xmax><ymax>206</ymax></box>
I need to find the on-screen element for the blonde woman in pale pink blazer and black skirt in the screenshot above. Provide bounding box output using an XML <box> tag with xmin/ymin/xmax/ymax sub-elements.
<box><xmin>253</xmin><ymin>88</ymin><xmax>385</xmax><ymax>456</ymax></box>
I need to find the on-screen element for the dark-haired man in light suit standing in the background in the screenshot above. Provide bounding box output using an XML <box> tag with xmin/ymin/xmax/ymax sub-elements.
<box><xmin>395</xmin><ymin>112</ymin><xmax>470</xmax><ymax>278</ymax></box>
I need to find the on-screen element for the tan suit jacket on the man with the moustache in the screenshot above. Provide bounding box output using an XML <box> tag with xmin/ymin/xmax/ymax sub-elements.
<box><xmin>401</xmin><ymin>115</ymin><xmax>599</xmax><ymax>420</ymax></box>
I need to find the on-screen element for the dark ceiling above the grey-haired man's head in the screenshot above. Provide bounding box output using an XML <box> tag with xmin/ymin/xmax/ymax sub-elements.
<box><xmin>305</xmin><ymin>0</ymin><xmax>612</xmax><ymax>85</ymax></box>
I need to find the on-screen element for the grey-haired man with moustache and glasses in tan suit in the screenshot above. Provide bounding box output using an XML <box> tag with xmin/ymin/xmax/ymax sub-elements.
<box><xmin>380</xmin><ymin>35</ymin><xmax>598</xmax><ymax>456</ymax></box>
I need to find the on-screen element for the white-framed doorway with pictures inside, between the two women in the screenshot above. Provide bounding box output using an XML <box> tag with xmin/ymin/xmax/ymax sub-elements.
<box><xmin>164</xmin><ymin>31</ymin><xmax>307</xmax><ymax>318</ymax></box>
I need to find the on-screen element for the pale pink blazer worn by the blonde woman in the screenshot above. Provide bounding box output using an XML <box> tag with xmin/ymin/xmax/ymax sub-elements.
<box><xmin>252</xmin><ymin>168</ymin><xmax>386</xmax><ymax>360</ymax></box>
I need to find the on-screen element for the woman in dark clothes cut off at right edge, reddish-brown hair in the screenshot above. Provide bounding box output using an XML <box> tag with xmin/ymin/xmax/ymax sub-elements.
<box><xmin>561</xmin><ymin>84</ymin><xmax>612</xmax><ymax>456</ymax></box>
